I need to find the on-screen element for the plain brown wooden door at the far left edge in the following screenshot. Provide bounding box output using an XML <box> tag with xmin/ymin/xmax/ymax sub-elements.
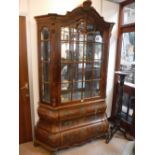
<box><xmin>19</xmin><ymin>16</ymin><xmax>32</xmax><ymax>143</ymax></box>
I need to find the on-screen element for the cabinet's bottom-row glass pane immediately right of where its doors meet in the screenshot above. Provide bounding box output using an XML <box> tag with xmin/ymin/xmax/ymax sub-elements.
<box><xmin>83</xmin><ymin>81</ymin><xmax>92</xmax><ymax>98</ymax></box>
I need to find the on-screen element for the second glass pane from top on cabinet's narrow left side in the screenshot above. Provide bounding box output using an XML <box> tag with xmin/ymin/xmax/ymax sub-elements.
<box><xmin>41</xmin><ymin>41</ymin><xmax>50</xmax><ymax>61</ymax></box>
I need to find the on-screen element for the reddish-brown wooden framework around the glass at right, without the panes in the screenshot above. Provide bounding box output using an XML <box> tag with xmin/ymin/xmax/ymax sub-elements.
<box><xmin>110</xmin><ymin>0</ymin><xmax>135</xmax><ymax>136</ymax></box>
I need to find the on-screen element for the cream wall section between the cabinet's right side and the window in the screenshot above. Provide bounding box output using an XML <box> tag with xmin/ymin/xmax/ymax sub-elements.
<box><xmin>101</xmin><ymin>0</ymin><xmax>119</xmax><ymax>117</ymax></box>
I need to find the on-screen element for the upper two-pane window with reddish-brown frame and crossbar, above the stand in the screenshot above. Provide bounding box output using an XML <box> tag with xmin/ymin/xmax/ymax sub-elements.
<box><xmin>116</xmin><ymin>0</ymin><xmax>135</xmax><ymax>84</ymax></box>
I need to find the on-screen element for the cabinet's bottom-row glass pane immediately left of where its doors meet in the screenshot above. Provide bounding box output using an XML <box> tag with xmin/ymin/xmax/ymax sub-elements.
<box><xmin>72</xmin><ymin>82</ymin><xmax>82</xmax><ymax>100</ymax></box>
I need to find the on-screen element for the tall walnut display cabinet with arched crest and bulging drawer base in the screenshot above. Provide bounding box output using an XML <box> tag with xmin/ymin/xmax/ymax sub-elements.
<box><xmin>35</xmin><ymin>1</ymin><xmax>113</xmax><ymax>154</ymax></box>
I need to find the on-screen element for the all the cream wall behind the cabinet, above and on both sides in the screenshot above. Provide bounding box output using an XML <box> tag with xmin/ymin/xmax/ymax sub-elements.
<box><xmin>19</xmin><ymin>0</ymin><xmax>119</xmax><ymax>131</ymax></box>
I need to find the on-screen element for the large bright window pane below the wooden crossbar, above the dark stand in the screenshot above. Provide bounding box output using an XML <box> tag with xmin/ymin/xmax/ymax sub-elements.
<box><xmin>121</xmin><ymin>32</ymin><xmax>135</xmax><ymax>83</ymax></box>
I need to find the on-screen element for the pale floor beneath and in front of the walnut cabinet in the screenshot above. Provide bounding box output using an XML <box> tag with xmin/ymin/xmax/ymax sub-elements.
<box><xmin>19</xmin><ymin>135</ymin><xmax>134</xmax><ymax>155</ymax></box>
